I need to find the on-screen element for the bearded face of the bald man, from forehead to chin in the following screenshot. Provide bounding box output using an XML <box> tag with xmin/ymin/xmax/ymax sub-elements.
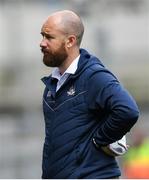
<box><xmin>40</xmin><ymin>21</ymin><xmax>68</xmax><ymax>67</ymax></box>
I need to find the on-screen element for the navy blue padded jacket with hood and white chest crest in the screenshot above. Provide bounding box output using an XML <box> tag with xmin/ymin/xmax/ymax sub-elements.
<box><xmin>42</xmin><ymin>49</ymin><xmax>139</xmax><ymax>179</ymax></box>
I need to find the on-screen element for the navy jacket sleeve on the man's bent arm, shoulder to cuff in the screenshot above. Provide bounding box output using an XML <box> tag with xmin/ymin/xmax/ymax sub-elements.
<box><xmin>88</xmin><ymin>70</ymin><xmax>139</xmax><ymax>146</ymax></box>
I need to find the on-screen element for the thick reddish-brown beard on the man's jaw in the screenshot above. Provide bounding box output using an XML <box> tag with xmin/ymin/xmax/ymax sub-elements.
<box><xmin>43</xmin><ymin>45</ymin><xmax>68</xmax><ymax>67</ymax></box>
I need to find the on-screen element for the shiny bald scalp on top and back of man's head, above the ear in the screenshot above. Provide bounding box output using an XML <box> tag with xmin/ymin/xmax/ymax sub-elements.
<box><xmin>48</xmin><ymin>10</ymin><xmax>84</xmax><ymax>46</ymax></box>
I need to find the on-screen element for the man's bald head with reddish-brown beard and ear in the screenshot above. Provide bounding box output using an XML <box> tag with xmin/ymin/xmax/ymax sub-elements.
<box><xmin>40</xmin><ymin>10</ymin><xmax>84</xmax><ymax>67</ymax></box>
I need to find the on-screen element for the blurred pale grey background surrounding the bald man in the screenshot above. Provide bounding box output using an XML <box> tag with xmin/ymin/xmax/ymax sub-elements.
<box><xmin>0</xmin><ymin>0</ymin><xmax>149</xmax><ymax>179</ymax></box>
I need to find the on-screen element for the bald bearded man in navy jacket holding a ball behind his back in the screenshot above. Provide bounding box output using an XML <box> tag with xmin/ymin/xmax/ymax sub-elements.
<box><xmin>40</xmin><ymin>10</ymin><xmax>139</xmax><ymax>179</ymax></box>
